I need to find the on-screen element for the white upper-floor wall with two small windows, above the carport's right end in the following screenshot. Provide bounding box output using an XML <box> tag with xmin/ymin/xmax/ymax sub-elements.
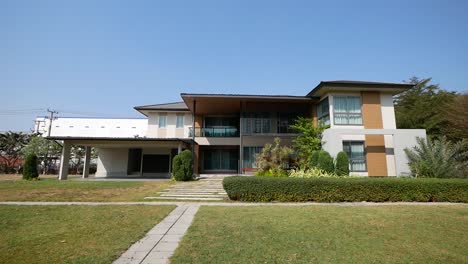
<box><xmin>146</xmin><ymin>112</ymin><xmax>193</xmax><ymax>138</ymax></box>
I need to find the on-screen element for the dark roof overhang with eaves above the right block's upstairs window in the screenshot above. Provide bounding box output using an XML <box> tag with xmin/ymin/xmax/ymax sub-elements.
<box><xmin>307</xmin><ymin>81</ymin><xmax>414</xmax><ymax>97</ymax></box>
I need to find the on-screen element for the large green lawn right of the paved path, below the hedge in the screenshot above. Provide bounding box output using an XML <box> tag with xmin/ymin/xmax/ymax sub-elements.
<box><xmin>171</xmin><ymin>205</ymin><xmax>468</xmax><ymax>263</ymax></box>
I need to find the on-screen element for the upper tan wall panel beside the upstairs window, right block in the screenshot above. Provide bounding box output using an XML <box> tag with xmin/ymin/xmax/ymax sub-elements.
<box><xmin>361</xmin><ymin>92</ymin><xmax>383</xmax><ymax>128</ymax></box>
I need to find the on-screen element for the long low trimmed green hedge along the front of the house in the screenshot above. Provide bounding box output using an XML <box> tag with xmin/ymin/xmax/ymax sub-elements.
<box><xmin>223</xmin><ymin>176</ymin><xmax>468</xmax><ymax>203</ymax></box>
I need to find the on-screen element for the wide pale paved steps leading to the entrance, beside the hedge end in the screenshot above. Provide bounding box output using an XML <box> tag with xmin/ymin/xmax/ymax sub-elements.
<box><xmin>145</xmin><ymin>177</ymin><xmax>228</xmax><ymax>201</ymax></box>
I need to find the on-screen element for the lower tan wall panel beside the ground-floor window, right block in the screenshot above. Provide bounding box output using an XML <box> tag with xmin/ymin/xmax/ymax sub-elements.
<box><xmin>366</xmin><ymin>135</ymin><xmax>388</xmax><ymax>176</ymax></box>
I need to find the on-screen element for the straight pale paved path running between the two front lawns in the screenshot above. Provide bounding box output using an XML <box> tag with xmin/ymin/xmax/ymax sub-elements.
<box><xmin>114</xmin><ymin>204</ymin><xmax>200</xmax><ymax>264</ymax></box>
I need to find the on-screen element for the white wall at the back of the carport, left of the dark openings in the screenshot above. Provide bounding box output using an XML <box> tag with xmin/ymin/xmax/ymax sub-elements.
<box><xmin>95</xmin><ymin>148</ymin><xmax>128</xmax><ymax>177</ymax></box>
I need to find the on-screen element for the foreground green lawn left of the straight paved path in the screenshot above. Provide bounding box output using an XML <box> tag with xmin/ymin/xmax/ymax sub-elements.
<box><xmin>0</xmin><ymin>205</ymin><xmax>174</xmax><ymax>263</ymax></box>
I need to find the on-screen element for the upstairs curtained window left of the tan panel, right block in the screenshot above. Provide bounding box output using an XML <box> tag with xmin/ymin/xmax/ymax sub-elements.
<box><xmin>333</xmin><ymin>96</ymin><xmax>362</xmax><ymax>125</ymax></box>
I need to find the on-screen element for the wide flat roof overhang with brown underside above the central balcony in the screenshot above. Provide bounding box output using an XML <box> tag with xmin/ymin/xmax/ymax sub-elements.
<box><xmin>181</xmin><ymin>93</ymin><xmax>319</xmax><ymax>114</ymax></box>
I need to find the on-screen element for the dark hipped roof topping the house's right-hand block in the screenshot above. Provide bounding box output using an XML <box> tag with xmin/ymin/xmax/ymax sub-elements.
<box><xmin>307</xmin><ymin>80</ymin><xmax>414</xmax><ymax>96</ymax></box>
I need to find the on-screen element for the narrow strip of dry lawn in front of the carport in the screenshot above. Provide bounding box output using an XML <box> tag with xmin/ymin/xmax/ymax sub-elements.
<box><xmin>0</xmin><ymin>178</ymin><xmax>172</xmax><ymax>202</ymax></box>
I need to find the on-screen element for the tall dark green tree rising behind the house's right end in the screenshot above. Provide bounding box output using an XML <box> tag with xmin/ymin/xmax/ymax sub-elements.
<box><xmin>394</xmin><ymin>77</ymin><xmax>457</xmax><ymax>137</ymax></box>
